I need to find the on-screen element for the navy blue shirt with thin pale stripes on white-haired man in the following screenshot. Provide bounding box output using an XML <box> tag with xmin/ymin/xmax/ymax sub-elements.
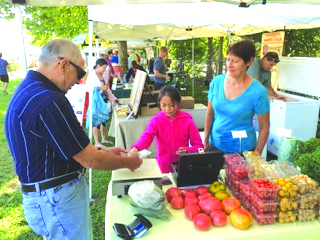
<box><xmin>5</xmin><ymin>70</ymin><xmax>90</xmax><ymax>183</ymax></box>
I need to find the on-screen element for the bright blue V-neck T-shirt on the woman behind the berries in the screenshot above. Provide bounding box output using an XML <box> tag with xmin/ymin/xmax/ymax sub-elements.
<box><xmin>208</xmin><ymin>74</ymin><xmax>270</xmax><ymax>152</ymax></box>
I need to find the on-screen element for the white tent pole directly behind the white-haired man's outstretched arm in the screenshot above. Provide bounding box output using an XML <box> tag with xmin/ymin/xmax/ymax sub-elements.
<box><xmin>88</xmin><ymin>20</ymin><xmax>94</xmax><ymax>201</ymax></box>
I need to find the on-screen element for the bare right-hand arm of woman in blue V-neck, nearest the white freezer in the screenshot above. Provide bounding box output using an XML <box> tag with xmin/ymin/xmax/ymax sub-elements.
<box><xmin>254</xmin><ymin>112</ymin><xmax>270</xmax><ymax>155</ymax></box>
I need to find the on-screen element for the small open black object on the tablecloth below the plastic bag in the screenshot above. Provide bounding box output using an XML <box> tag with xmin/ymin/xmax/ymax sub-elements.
<box><xmin>113</xmin><ymin>214</ymin><xmax>152</xmax><ymax>239</ymax></box>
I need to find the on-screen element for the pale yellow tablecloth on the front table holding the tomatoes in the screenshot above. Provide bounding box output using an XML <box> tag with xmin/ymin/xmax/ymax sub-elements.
<box><xmin>105</xmin><ymin>176</ymin><xmax>320</xmax><ymax>240</ymax></box>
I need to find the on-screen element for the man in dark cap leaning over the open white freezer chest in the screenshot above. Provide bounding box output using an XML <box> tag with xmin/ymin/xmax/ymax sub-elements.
<box><xmin>247</xmin><ymin>52</ymin><xmax>286</xmax><ymax>101</ymax></box>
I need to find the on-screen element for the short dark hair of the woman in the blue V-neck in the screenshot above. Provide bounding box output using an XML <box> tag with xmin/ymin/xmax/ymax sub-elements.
<box><xmin>227</xmin><ymin>39</ymin><xmax>256</xmax><ymax>63</ymax></box>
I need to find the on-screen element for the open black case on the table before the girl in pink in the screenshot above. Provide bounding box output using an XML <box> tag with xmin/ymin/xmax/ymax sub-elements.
<box><xmin>172</xmin><ymin>151</ymin><xmax>224</xmax><ymax>187</ymax></box>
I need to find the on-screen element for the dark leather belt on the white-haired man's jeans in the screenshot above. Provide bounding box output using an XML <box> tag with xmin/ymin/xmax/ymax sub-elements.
<box><xmin>21</xmin><ymin>171</ymin><xmax>85</xmax><ymax>193</ymax></box>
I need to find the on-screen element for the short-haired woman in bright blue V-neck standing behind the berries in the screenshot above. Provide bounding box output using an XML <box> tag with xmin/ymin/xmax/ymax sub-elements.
<box><xmin>204</xmin><ymin>40</ymin><xmax>270</xmax><ymax>154</ymax></box>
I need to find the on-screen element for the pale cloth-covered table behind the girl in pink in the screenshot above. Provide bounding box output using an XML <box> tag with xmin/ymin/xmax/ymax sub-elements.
<box><xmin>108</xmin><ymin>99</ymin><xmax>207</xmax><ymax>157</ymax></box>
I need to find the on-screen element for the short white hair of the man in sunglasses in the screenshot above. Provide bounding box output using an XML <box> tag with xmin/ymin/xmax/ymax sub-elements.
<box><xmin>38</xmin><ymin>39</ymin><xmax>82</xmax><ymax>65</ymax></box>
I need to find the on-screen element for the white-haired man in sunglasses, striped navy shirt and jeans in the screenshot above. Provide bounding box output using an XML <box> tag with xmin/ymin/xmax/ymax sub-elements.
<box><xmin>5</xmin><ymin>39</ymin><xmax>142</xmax><ymax>240</ymax></box>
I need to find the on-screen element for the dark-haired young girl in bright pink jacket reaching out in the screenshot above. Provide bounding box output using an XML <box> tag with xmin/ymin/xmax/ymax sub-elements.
<box><xmin>129</xmin><ymin>85</ymin><xmax>203</xmax><ymax>173</ymax></box>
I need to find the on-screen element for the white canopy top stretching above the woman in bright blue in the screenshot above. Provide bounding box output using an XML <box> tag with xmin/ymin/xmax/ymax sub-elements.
<box><xmin>88</xmin><ymin>2</ymin><xmax>320</xmax><ymax>40</ymax></box>
